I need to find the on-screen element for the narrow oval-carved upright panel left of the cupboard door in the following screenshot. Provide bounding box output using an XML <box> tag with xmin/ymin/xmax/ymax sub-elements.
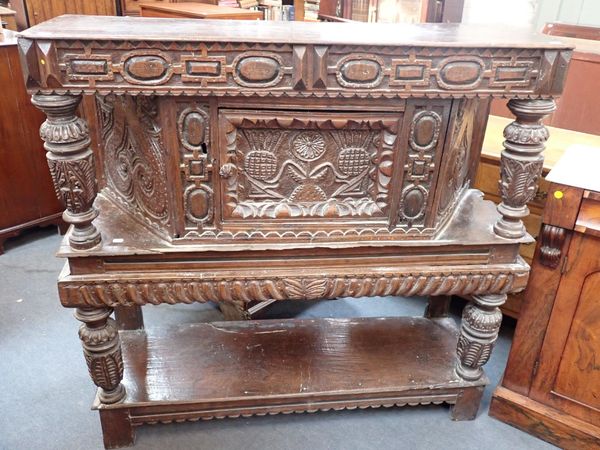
<box><xmin>177</xmin><ymin>102</ymin><xmax>215</xmax><ymax>231</ymax></box>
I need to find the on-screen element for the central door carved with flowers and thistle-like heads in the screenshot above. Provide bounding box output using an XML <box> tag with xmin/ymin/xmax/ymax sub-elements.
<box><xmin>220</xmin><ymin>112</ymin><xmax>398</xmax><ymax>221</ymax></box>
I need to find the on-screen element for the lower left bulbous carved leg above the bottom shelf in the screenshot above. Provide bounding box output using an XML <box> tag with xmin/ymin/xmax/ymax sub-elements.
<box><xmin>75</xmin><ymin>308</ymin><xmax>125</xmax><ymax>404</ymax></box>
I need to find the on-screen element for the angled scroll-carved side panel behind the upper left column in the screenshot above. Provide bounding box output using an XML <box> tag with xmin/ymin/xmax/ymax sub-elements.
<box><xmin>97</xmin><ymin>95</ymin><xmax>171</xmax><ymax>234</ymax></box>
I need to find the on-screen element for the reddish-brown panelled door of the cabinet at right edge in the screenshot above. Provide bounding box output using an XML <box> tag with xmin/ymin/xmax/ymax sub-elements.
<box><xmin>531</xmin><ymin>233</ymin><xmax>600</xmax><ymax>426</ymax></box>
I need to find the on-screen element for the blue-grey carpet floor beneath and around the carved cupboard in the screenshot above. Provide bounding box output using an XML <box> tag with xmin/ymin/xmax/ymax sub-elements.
<box><xmin>0</xmin><ymin>229</ymin><xmax>553</xmax><ymax>450</ymax></box>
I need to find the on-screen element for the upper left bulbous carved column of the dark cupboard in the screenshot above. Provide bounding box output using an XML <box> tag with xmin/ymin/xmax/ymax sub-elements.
<box><xmin>31</xmin><ymin>95</ymin><xmax>101</xmax><ymax>250</ymax></box>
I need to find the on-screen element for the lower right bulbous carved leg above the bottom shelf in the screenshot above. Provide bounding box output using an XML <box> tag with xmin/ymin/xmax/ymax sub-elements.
<box><xmin>456</xmin><ymin>294</ymin><xmax>506</xmax><ymax>381</ymax></box>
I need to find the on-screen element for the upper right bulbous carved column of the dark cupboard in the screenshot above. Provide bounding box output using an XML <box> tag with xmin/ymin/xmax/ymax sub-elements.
<box><xmin>494</xmin><ymin>100</ymin><xmax>556</xmax><ymax>239</ymax></box>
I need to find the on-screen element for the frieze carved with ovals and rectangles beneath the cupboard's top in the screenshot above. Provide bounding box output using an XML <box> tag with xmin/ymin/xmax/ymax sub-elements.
<box><xmin>20</xmin><ymin>38</ymin><xmax>569</xmax><ymax>98</ymax></box>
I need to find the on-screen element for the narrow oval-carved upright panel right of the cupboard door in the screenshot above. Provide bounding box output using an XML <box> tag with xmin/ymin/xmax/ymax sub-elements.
<box><xmin>396</xmin><ymin>103</ymin><xmax>449</xmax><ymax>231</ymax></box>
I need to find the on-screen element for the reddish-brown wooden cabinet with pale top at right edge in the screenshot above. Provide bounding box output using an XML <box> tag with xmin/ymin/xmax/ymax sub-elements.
<box><xmin>490</xmin><ymin>148</ymin><xmax>600</xmax><ymax>449</ymax></box>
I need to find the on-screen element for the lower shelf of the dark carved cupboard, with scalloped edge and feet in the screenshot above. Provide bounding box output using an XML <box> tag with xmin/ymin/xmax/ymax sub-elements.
<box><xmin>95</xmin><ymin>318</ymin><xmax>487</xmax><ymax>447</ymax></box>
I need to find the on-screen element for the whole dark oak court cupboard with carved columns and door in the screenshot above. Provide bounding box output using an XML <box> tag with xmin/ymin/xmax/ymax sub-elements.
<box><xmin>19</xmin><ymin>16</ymin><xmax>570</xmax><ymax>447</ymax></box>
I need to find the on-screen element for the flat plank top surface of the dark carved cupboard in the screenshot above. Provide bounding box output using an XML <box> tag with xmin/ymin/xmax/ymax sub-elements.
<box><xmin>21</xmin><ymin>15</ymin><xmax>572</xmax><ymax>49</ymax></box>
